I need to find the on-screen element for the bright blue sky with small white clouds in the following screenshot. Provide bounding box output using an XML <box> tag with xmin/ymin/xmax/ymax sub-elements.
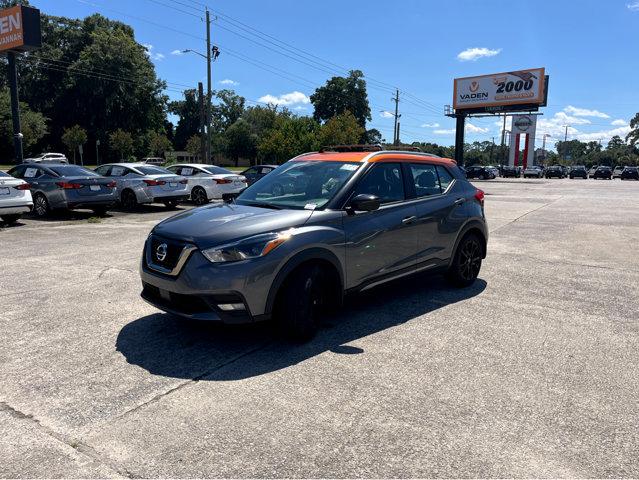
<box><xmin>31</xmin><ymin>0</ymin><xmax>639</xmax><ymax>145</ymax></box>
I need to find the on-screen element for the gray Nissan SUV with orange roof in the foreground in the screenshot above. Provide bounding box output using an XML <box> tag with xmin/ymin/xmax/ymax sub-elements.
<box><xmin>141</xmin><ymin>148</ymin><xmax>488</xmax><ymax>339</ymax></box>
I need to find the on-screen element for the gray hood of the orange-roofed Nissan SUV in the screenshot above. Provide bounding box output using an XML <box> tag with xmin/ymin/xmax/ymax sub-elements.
<box><xmin>152</xmin><ymin>203</ymin><xmax>313</xmax><ymax>248</ymax></box>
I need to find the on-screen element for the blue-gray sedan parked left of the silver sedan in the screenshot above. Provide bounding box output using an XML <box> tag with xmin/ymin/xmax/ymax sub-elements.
<box><xmin>9</xmin><ymin>163</ymin><xmax>116</xmax><ymax>217</ymax></box>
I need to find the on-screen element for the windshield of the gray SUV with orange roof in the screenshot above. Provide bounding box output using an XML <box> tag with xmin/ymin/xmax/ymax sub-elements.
<box><xmin>236</xmin><ymin>160</ymin><xmax>361</xmax><ymax>209</ymax></box>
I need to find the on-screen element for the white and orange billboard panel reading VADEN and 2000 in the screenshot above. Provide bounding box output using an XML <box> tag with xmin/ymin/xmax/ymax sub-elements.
<box><xmin>453</xmin><ymin>68</ymin><xmax>546</xmax><ymax>111</ymax></box>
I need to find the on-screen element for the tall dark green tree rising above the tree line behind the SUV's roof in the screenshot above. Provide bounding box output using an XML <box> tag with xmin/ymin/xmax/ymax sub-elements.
<box><xmin>311</xmin><ymin>70</ymin><xmax>371</xmax><ymax>128</ymax></box>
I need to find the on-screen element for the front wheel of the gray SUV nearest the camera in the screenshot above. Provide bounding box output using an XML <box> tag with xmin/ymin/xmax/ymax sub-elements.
<box><xmin>275</xmin><ymin>265</ymin><xmax>328</xmax><ymax>342</ymax></box>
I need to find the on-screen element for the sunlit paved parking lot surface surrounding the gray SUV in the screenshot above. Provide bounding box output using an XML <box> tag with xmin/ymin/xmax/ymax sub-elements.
<box><xmin>0</xmin><ymin>180</ymin><xmax>639</xmax><ymax>477</ymax></box>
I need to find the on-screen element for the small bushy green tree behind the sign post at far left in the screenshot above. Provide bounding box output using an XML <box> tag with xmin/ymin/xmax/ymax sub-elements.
<box><xmin>0</xmin><ymin>88</ymin><xmax>47</xmax><ymax>158</ymax></box>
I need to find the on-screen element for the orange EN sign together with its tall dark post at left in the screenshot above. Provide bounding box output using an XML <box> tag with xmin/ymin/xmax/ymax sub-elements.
<box><xmin>0</xmin><ymin>5</ymin><xmax>42</xmax><ymax>163</ymax></box>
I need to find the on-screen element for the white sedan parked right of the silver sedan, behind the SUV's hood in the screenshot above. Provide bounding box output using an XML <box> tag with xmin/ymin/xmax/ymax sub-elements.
<box><xmin>168</xmin><ymin>163</ymin><xmax>247</xmax><ymax>205</ymax></box>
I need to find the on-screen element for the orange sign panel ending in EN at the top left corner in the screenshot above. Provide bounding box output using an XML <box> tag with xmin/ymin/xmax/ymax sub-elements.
<box><xmin>0</xmin><ymin>5</ymin><xmax>42</xmax><ymax>52</ymax></box>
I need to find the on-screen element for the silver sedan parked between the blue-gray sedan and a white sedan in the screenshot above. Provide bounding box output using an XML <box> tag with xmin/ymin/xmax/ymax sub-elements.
<box><xmin>95</xmin><ymin>163</ymin><xmax>190</xmax><ymax>210</ymax></box>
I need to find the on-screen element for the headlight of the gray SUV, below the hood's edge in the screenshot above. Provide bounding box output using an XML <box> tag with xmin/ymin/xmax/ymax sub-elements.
<box><xmin>202</xmin><ymin>231</ymin><xmax>293</xmax><ymax>263</ymax></box>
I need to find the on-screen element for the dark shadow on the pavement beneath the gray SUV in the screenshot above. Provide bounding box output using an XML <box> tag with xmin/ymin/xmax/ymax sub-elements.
<box><xmin>116</xmin><ymin>275</ymin><xmax>487</xmax><ymax>381</ymax></box>
